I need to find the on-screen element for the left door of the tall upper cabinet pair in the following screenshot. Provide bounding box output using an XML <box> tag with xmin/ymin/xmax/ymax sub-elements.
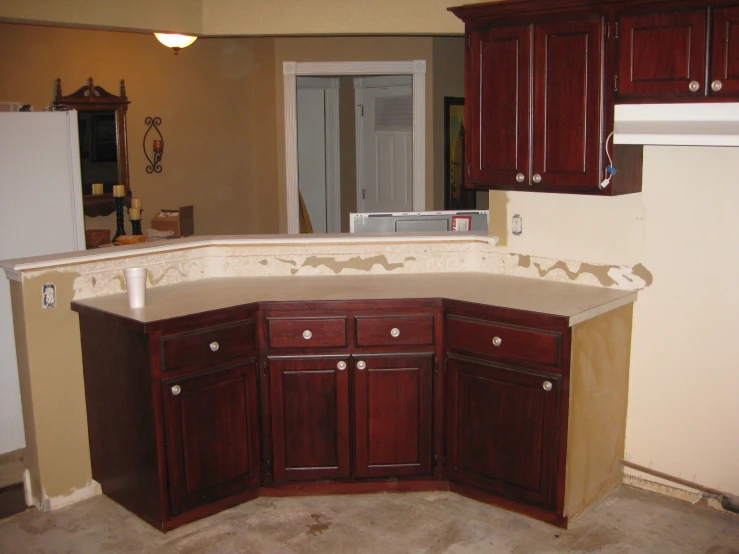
<box><xmin>467</xmin><ymin>25</ymin><xmax>531</xmax><ymax>188</ymax></box>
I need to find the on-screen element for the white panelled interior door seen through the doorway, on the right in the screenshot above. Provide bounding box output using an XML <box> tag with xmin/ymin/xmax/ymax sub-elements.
<box><xmin>355</xmin><ymin>76</ymin><xmax>413</xmax><ymax>212</ymax></box>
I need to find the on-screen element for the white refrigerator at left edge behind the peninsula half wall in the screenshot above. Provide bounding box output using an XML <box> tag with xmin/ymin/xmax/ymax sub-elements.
<box><xmin>0</xmin><ymin>111</ymin><xmax>85</xmax><ymax>454</ymax></box>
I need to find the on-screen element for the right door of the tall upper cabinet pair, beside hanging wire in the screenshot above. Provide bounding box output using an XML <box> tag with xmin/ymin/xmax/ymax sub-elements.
<box><xmin>531</xmin><ymin>20</ymin><xmax>603</xmax><ymax>192</ymax></box>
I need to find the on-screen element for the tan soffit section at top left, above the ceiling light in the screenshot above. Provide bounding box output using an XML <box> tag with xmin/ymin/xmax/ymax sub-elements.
<box><xmin>0</xmin><ymin>0</ymin><xmax>203</xmax><ymax>34</ymax></box>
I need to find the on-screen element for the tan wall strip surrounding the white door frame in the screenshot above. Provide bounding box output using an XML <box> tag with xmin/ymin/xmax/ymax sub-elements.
<box><xmin>274</xmin><ymin>37</ymin><xmax>434</xmax><ymax>232</ymax></box>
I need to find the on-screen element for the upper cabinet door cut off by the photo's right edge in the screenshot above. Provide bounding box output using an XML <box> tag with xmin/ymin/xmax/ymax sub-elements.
<box><xmin>709</xmin><ymin>7</ymin><xmax>739</xmax><ymax>97</ymax></box>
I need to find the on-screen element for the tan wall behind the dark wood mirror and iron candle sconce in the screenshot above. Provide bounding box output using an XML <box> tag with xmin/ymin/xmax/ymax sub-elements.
<box><xmin>0</xmin><ymin>23</ymin><xmax>276</xmax><ymax>234</ymax></box>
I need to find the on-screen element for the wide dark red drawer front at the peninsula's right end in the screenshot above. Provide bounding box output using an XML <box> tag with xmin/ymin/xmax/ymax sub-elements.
<box><xmin>446</xmin><ymin>316</ymin><xmax>562</xmax><ymax>367</ymax></box>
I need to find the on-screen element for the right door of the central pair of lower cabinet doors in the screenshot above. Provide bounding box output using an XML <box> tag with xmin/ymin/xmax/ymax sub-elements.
<box><xmin>354</xmin><ymin>354</ymin><xmax>434</xmax><ymax>477</ymax></box>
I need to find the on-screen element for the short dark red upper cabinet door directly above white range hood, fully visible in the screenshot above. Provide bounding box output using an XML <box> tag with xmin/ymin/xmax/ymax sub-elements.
<box><xmin>618</xmin><ymin>9</ymin><xmax>708</xmax><ymax>98</ymax></box>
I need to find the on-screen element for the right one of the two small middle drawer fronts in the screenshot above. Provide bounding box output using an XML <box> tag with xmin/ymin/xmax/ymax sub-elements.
<box><xmin>356</xmin><ymin>314</ymin><xmax>434</xmax><ymax>346</ymax></box>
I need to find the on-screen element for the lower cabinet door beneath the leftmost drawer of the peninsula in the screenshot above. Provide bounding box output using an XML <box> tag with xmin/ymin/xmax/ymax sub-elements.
<box><xmin>163</xmin><ymin>360</ymin><xmax>259</xmax><ymax>515</ymax></box>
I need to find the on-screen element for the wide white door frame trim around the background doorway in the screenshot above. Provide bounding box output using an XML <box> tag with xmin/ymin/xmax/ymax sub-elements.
<box><xmin>282</xmin><ymin>60</ymin><xmax>426</xmax><ymax>234</ymax></box>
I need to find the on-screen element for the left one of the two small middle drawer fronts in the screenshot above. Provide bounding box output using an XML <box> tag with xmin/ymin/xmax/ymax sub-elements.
<box><xmin>267</xmin><ymin>317</ymin><xmax>346</xmax><ymax>348</ymax></box>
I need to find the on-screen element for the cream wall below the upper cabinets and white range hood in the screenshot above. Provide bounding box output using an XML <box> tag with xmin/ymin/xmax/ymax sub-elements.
<box><xmin>490</xmin><ymin>146</ymin><xmax>739</xmax><ymax>494</ymax></box>
